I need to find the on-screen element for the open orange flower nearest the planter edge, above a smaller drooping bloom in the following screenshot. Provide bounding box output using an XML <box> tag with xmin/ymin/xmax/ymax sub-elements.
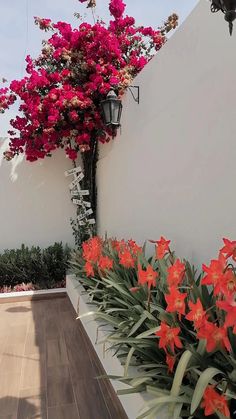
<box><xmin>155</xmin><ymin>322</ymin><xmax>183</xmax><ymax>354</ymax></box>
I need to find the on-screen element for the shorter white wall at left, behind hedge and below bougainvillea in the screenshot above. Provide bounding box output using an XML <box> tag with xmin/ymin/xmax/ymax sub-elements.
<box><xmin>0</xmin><ymin>143</ymin><xmax>74</xmax><ymax>251</ymax></box>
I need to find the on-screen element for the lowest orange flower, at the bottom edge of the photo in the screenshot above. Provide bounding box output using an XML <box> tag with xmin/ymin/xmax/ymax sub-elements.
<box><xmin>201</xmin><ymin>386</ymin><xmax>230</xmax><ymax>418</ymax></box>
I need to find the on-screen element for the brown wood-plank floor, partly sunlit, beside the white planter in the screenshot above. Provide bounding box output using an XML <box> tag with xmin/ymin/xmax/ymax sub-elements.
<box><xmin>0</xmin><ymin>297</ymin><xmax>127</xmax><ymax>419</ymax></box>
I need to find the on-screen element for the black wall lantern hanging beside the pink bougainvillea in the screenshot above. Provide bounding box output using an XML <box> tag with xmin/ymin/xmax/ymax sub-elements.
<box><xmin>101</xmin><ymin>90</ymin><xmax>123</xmax><ymax>128</ymax></box>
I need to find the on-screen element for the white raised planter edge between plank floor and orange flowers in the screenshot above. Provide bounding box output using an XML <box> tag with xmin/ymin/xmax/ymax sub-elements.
<box><xmin>66</xmin><ymin>275</ymin><xmax>149</xmax><ymax>419</ymax></box>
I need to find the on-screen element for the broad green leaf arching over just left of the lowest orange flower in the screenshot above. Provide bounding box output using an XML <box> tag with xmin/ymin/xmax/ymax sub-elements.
<box><xmin>190</xmin><ymin>367</ymin><xmax>224</xmax><ymax>415</ymax></box>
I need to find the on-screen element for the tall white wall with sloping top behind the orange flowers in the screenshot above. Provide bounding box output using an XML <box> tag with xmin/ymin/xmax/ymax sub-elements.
<box><xmin>98</xmin><ymin>0</ymin><xmax>236</xmax><ymax>264</ymax></box>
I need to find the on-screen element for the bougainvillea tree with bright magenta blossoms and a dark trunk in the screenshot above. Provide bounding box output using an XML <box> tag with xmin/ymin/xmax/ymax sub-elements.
<box><xmin>0</xmin><ymin>0</ymin><xmax>178</xmax><ymax>238</ymax></box>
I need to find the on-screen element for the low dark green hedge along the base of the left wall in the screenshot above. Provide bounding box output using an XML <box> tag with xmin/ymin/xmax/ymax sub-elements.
<box><xmin>0</xmin><ymin>243</ymin><xmax>70</xmax><ymax>288</ymax></box>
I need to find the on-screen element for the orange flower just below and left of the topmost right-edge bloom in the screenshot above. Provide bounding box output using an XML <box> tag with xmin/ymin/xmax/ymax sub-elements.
<box><xmin>202</xmin><ymin>254</ymin><xmax>226</xmax><ymax>295</ymax></box>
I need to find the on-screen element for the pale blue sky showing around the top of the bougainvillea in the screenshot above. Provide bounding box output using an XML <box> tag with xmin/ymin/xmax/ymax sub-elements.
<box><xmin>0</xmin><ymin>0</ymin><xmax>198</xmax><ymax>137</ymax></box>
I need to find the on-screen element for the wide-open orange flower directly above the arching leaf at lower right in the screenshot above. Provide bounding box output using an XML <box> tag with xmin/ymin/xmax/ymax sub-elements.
<box><xmin>197</xmin><ymin>320</ymin><xmax>231</xmax><ymax>352</ymax></box>
